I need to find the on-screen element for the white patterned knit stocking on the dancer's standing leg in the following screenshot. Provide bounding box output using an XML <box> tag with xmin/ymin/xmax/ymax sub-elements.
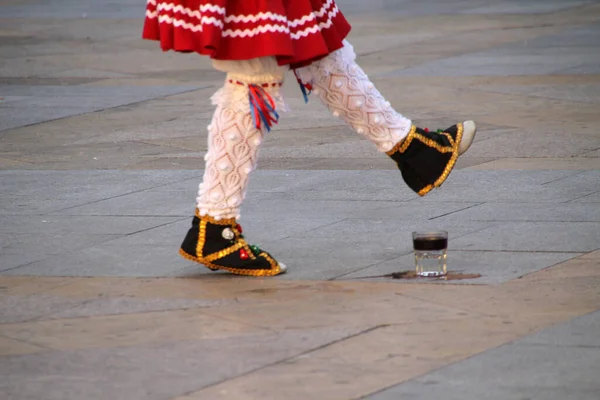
<box><xmin>197</xmin><ymin>74</ymin><xmax>284</xmax><ymax>219</ymax></box>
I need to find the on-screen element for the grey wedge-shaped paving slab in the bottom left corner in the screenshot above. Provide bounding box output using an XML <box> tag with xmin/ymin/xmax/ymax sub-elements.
<box><xmin>0</xmin><ymin>329</ymin><xmax>364</xmax><ymax>400</ymax></box>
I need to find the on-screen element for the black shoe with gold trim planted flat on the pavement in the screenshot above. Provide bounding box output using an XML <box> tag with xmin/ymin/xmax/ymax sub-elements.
<box><xmin>179</xmin><ymin>210</ymin><xmax>286</xmax><ymax>276</ymax></box>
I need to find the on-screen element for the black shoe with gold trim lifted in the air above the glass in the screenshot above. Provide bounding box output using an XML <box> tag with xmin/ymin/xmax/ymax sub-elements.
<box><xmin>387</xmin><ymin>121</ymin><xmax>477</xmax><ymax>196</ymax></box>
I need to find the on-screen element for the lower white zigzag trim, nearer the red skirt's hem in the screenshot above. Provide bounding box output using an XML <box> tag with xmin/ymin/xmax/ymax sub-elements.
<box><xmin>146</xmin><ymin>6</ymin><xmax>339</xmax><ymax>40</ymax></box>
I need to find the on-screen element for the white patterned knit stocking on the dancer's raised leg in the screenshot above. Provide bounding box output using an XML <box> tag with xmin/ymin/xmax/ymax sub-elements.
<box><xmin>296</xmin><ymin>41</ymin><xmax>412</xmax><ymax>152</ymax></box>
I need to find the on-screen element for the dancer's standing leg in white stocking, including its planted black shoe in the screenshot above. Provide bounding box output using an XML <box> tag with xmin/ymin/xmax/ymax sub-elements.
<box><xmin>180</xmin><ymin>58</ymin><xmax>285</xmax><ymax>276</ymax></box>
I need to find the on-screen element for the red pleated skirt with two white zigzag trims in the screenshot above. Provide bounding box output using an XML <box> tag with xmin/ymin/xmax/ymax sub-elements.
<box><xmin>143</xmin><ymin>0</ymin><xmax>350</xmax><ymax>68</ymax></box>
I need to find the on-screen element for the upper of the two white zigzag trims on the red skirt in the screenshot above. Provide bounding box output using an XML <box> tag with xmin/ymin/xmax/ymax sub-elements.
<box><xmin>146</xmin><ymin>0</ymin><xmax>337</xmax><ymax>28</ymax></box>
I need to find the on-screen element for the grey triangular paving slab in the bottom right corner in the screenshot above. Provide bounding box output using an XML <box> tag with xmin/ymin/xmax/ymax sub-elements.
<box><xmin>365</xmin><ymin>313</ymin><xmax>600</xmax><ymax>400</ymax></box>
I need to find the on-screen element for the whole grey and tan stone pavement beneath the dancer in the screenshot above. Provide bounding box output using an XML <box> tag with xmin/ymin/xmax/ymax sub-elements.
<box><xmin>0</xmin><ymin>0</ymin><xmax>600</xmax><ymax>400</ymax></box>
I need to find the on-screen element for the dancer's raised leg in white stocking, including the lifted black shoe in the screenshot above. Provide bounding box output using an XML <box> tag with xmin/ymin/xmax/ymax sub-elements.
<box><xmin>296</xmin><ymin>42</ymin><xmax>475</xmax><ymax>196</ymax></box>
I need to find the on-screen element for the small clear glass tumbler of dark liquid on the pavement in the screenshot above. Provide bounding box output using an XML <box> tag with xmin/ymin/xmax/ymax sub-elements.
<box><xmin>413</xmin><ymin>231</ymin><xmax>448</xmax><ymax>277</ymax></box>
